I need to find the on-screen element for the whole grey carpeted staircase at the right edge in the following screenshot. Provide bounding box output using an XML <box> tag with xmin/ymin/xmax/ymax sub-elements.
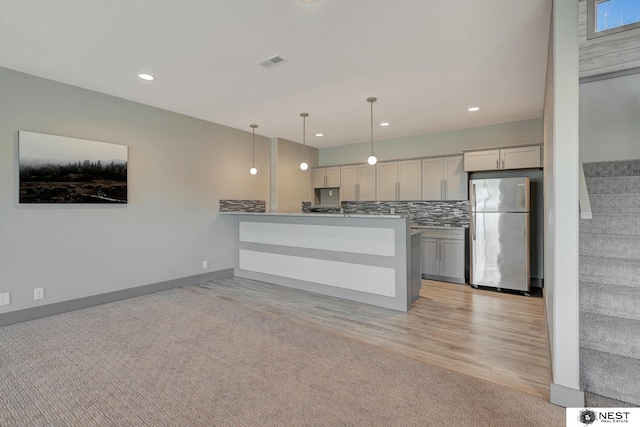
<box><xmin>580</xmin><ymin>160</ymin><xmax>640</xmax><ymax>405</ymax></box>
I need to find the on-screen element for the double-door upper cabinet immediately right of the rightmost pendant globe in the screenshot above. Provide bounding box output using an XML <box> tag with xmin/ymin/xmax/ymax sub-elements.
<box><xmin>376</xmin><ymin>160</ymin><xmax>422</xmax><ymax>200</ymax></box>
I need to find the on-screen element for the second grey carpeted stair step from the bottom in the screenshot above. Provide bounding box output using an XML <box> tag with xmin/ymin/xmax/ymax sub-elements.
<box><xmin>580</xmin><ymin>312</ymin><xmax>640</xmax><ymax>358</ymax></box>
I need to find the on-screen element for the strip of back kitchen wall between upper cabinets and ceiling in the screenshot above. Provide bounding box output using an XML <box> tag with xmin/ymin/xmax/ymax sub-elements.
<box><xmin>320</xmin><ymin>118</ymin><xmax>542</xmax><ymax>166</ymax></box>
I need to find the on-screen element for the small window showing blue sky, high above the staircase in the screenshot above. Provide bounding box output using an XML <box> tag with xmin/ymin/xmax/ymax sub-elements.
<box><xmin>587</xmin><ymin>0</ymin><xmax>640</xmax><ymax>39</ymax></box>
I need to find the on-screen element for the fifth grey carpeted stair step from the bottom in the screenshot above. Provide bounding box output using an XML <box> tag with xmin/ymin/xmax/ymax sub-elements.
<box><xmin>580</xmin><ymin>233</ymin><xmax>640</xmax><ymax>259</ymax></box>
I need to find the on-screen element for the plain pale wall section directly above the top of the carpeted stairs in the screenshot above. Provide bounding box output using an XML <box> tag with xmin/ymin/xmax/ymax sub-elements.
<box><xmin>580</xmin><ymin>74</ymin><xmax>640</xmax><ymax>162</ymax></box>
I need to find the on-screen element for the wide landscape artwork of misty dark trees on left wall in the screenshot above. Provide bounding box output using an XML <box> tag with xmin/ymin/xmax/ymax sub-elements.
<box><xmin>18</xmin><ymin>131</ymin><xmax>128</xmax><ymax>203</ymax></box>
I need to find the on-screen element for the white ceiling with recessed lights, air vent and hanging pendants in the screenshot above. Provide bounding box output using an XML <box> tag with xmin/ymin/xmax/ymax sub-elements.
<box><xmin>0</xmin><ymin>0</ymin><xmax>551</xmax><ymax>148</ymax></box>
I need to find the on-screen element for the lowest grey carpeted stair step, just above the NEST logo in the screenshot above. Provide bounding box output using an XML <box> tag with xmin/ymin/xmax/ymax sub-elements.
<box><xmin>580</xmin><ymin>348</ymin><xmax>640</xmax><ymax>405</ymax></box>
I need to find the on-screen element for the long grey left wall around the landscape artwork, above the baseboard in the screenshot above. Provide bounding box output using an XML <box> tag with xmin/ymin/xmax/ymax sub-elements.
<box><xmin>0</xmin><ymin>68</ymin><xmax>270</xmax><ymax>314</ymax></box>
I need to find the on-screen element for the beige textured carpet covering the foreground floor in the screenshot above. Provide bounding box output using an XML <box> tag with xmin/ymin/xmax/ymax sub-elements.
<box><xmin>0</xmin><ymin>287</ymin><xmax>565</xmax><ymax>427</ymax></box>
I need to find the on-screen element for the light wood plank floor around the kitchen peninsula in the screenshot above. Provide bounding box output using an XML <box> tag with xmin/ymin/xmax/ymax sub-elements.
<box><xmin>200</xmin><ymin>277</ymin><xmax>549</xmax><ymax>399</ymax></box>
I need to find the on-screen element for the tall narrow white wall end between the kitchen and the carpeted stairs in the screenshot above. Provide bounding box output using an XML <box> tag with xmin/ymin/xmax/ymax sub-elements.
<box><xmin>545</xmin><ymin>0</ymin><xmax>584</xmax><ymax>406</ymax></box>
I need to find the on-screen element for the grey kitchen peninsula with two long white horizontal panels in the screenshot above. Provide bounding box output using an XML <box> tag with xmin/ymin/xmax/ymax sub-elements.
<box><xmin>221</xmin><ymin>212</ymin><xmax>420</xmax><ymax>311</ymax></box>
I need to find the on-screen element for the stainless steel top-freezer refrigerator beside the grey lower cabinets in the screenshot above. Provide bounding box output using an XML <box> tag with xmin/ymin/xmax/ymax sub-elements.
<box><xmin>469</xmin><ymin>177</ymin><xmax>531</xmax><ymax>295</ymax></box>
